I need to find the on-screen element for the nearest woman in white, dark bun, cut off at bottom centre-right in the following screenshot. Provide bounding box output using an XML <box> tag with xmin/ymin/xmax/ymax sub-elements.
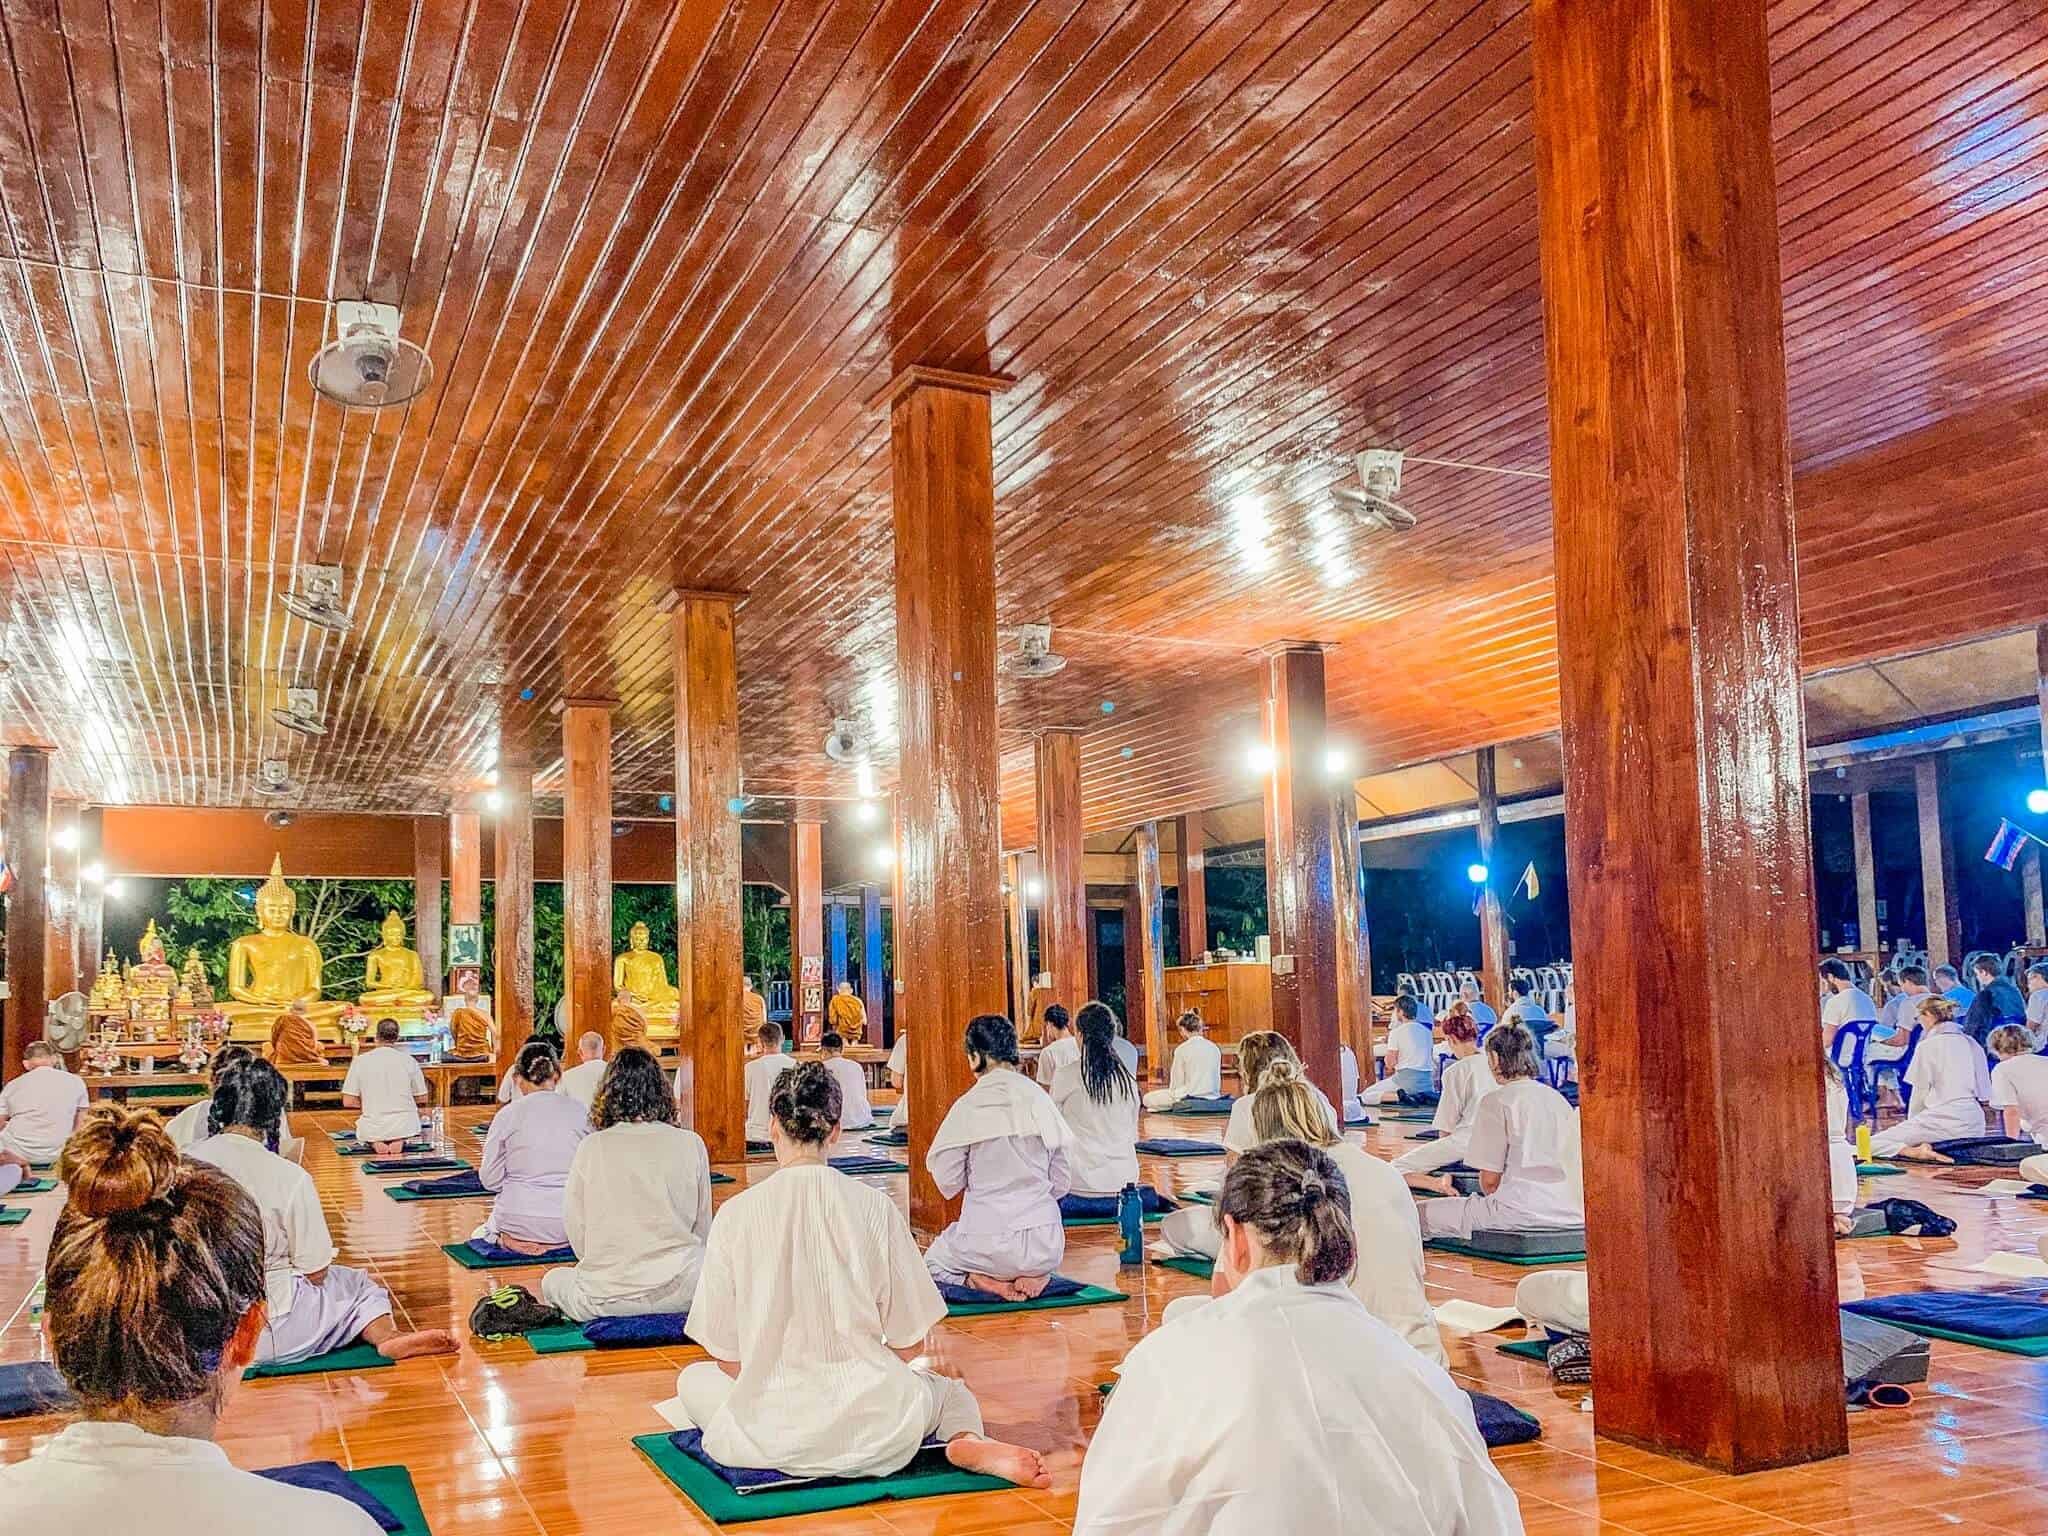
<box><xmin>1073</xmin><ymin>1146</ymin><xmax>1522</xmax><ymax>1536</ymax></box>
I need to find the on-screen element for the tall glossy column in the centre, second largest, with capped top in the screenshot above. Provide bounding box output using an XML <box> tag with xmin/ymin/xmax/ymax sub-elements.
<box><xmin>889</xmin><ymin>367</ymin><xmax>1007</xmax><ymax>1231</ymax></box>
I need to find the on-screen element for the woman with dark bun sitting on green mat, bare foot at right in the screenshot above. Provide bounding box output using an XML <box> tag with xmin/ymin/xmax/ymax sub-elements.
<box><xmin>664</xmin><ymin>1061</ymin><xmax>1051</xmax><ymax>1489</ymax></box>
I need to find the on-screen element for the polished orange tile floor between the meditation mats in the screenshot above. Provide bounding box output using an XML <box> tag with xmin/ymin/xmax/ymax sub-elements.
<box><xmin>0</xmin><ymin>1110</ymin><xmax>2048</xmax><ymax>1536</ymax></box>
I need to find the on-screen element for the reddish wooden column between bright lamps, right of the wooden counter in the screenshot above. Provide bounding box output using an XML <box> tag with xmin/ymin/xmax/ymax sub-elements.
<box><xmin>1266</xmin><ymin>645</ymin><xmax>1343</xmax><ymax>1102</ymax></box>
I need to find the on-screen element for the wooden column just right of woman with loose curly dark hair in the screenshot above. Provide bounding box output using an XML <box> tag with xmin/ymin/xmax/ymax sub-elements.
<box><xmin>676</xmin><ymin>592</ymin><xmax>748</xmax><ymax>1163</ymax></box>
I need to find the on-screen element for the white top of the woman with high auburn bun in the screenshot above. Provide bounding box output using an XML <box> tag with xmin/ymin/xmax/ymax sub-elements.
<box><xmin>0</xmin><ymin>1421</ymin><xmax>383</xmax><ymax>1536</ymax></box>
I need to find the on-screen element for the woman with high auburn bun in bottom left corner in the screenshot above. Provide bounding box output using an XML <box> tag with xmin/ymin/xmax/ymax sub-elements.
<box><xmin>0</xmin><ymin>1106</ymin><xmax>381</xmax><ymax>1536</ymax></box>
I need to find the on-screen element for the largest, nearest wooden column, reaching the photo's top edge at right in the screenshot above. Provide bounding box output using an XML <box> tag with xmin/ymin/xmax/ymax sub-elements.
<box><xmin>1532</xmin><ymin>0</ymin><xmax>1847</xmax><ymax>1473</ymax></box>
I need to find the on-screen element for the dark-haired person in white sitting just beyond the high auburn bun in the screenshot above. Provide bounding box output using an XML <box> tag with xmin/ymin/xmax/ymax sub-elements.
<box><xmin>190</xmin><ymin>1059</ymin><xmax>457</xmax><ymax>1364</ymax></box>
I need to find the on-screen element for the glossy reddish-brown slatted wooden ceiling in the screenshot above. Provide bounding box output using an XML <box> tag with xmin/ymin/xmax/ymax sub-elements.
<box><xmin>0</xmin><ymin>0</ymin><xmax>2048</xmax><ymax>844</ymax></box>
